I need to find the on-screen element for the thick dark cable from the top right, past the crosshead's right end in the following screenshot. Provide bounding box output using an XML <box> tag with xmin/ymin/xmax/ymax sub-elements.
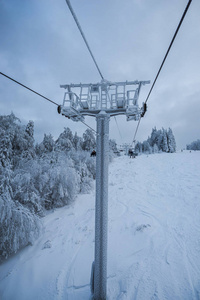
<box><xmin>131</xmin><ymin>0</ymin><xmax>192</xmax><ymax>146</ymax></box>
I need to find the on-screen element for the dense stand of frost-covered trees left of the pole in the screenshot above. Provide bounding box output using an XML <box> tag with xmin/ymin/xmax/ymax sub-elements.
<box><xmin>0</xmin><ymin>114</ymin><xmax>95</xmax><ymax>261</ymax></box>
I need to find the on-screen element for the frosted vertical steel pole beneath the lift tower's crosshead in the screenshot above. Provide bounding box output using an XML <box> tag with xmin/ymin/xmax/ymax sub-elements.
<box><xmin>93</xmin><ymin>111</ymin><xmax>110</xmax><ymax>300</ymax></box>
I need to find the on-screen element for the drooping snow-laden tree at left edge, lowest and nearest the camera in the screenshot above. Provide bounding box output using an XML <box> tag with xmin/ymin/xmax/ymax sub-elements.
<box><xmin>0</xmin><ymin>192</ymin><xmax>41</xmax><ymax>261</ymax></box>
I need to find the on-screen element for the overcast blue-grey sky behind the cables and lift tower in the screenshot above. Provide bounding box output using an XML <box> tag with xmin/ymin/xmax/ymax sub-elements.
<box><xmin>0</xmin><ymin>0</ymin><xmax>200</xmax><ymax>149</ymax></box>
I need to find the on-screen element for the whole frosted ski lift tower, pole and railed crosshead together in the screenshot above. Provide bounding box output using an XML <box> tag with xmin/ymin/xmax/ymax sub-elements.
<box><xmin>58</xmin><ymin>80</ymin><xmax>150</xmax><ymax>300</ymax></box>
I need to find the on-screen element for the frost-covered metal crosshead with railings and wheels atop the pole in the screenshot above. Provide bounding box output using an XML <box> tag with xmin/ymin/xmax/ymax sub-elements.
<box><xmin>58</xmin><ymin>80</ymin><xmax>150</xmax><ymax>121</ymax></box>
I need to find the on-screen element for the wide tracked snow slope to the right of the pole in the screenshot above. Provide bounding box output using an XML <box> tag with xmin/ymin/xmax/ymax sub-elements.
<box><xmin>109</xmin><ymin>154</ymin><xmax>200</xmax><ymax>300</ymax></box>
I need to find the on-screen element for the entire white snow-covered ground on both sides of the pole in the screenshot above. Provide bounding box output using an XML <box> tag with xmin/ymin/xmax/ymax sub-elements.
<box><xmin>0</xmin><ymin>151</ymin><xmax>200</xmax><ymax>300</ymax></box>
